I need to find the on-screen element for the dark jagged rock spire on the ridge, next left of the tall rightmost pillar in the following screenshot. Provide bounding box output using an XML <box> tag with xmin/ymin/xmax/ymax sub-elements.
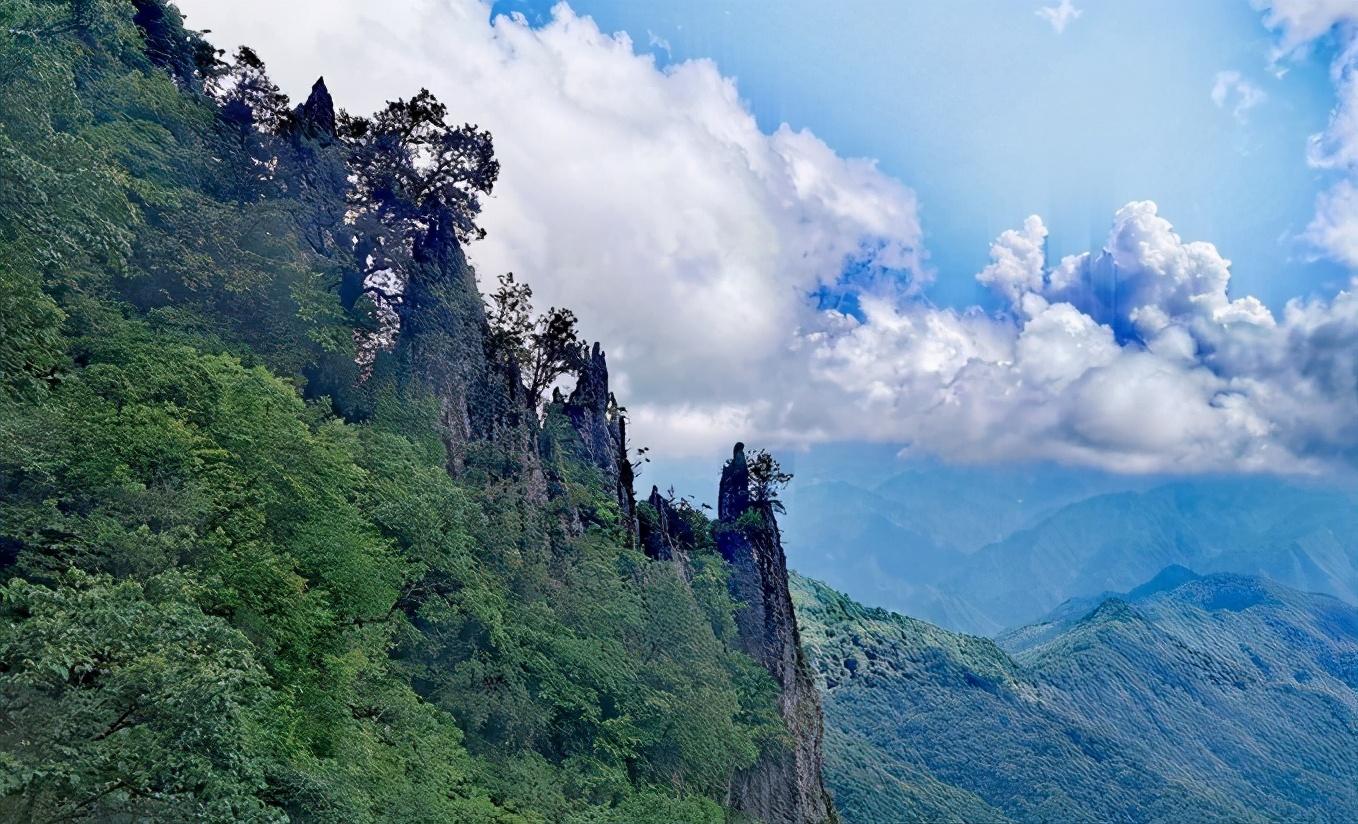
<box><xmin>565</xmin><ymin>343</ymin><xmax>637</xmax><ymax>539</ymax></box>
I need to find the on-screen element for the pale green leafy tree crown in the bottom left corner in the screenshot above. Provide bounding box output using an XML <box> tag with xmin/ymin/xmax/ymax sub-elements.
<box><xmin>0</xmin><ymin>572</ymin><xmax>281</xmax><ymax>821</ymax></box>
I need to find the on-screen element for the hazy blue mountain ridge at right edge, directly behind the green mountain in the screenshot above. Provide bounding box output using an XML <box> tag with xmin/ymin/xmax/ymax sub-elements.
<box><xmin>936</xmin><ymin>478</ymin><xmax>1358</xmax><ymax>634</ymax></box>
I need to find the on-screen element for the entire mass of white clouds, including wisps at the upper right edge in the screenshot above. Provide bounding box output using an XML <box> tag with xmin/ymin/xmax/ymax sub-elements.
<box><xmin>185</xmin><ymin>0</ymin><xmax>1358</xmax><ymax>472</ymax></box>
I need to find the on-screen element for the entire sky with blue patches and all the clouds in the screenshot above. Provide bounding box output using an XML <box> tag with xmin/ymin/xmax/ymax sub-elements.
<box><xmin>182</xmin><ymin>0</ymin><xmax>1358</xmax><ymax>475</ymax></box>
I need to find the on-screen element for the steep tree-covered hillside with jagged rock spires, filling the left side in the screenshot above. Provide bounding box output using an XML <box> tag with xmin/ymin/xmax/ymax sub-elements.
<box><xmin>0</xmin><ymin>0</ymin><xmax>835</xmax><ymax>824</ymax></box>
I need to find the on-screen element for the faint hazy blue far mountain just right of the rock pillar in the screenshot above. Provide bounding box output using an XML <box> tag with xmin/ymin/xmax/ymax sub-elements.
<box><xmin>784</xmin><ymin>461</ymin><xmax>1146</xmax><ymax>627</ymax></box>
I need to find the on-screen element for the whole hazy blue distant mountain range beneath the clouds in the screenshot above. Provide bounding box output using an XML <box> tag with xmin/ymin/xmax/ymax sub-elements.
<box><xmin>785</xmin><ymin>466</ymin><xmax>1358</xmax><ymax>635</ymax></box>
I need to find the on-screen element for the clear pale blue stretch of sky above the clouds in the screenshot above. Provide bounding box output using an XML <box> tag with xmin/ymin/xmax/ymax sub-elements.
<box><xmin>494</xmin><ymin>0</ymin><xmax>1347</xmax><ymax>308</ymax></box>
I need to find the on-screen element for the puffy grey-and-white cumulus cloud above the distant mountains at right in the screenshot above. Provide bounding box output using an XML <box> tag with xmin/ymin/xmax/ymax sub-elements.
<box><xmin>812</xmin><ymin>202</ymin><xmax>1358</xmax><ymax>472</ymax></box>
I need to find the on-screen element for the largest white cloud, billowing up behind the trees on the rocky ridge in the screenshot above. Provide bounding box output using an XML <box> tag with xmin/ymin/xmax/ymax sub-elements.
<box><xmin>177</xmin><ymin>0</ymin><xmax>922</xmax><ymax>448</ymax></box>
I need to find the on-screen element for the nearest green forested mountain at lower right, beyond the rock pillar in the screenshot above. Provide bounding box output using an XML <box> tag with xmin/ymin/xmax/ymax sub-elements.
<box><xmin>793</xmin><ymin>570</ymin><xmax>1358</xmax><ymax>824</ymax></box>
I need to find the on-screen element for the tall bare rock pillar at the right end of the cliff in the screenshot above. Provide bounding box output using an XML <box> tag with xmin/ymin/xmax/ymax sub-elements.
<box><xmin>716</xmin><ymin>444</ymin><xmax>838</xmax><ymax>824</ymax></box>
